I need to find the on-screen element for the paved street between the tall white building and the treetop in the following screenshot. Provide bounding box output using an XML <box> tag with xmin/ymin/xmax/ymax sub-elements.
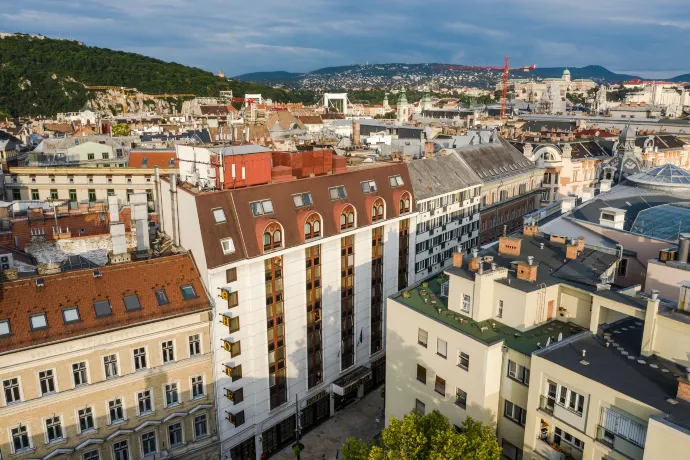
<box><xmin>271</xmin><ymin>389</ymin><xmax>385</xmax><ymax>460</ymax></box>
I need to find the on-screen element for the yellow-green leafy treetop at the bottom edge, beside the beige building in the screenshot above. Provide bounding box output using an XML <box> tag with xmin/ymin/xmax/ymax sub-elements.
<box><xmin>343</xmin><ymin>411</ymin><xmax>501</xmax><ymax>460</ymax></box>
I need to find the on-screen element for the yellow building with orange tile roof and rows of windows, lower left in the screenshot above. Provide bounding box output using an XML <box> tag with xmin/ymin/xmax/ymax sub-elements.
<box><xmin>0</xmin><ymin>253</ymin><xmax>218</xmax><ymax>460</ymax></box>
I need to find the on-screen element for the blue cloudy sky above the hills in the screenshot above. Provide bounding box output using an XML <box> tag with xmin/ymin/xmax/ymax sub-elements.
<box><xmin>5</xmin><ymin>0</ymin><xmax>690</xmax><ymax>78</ymax></box>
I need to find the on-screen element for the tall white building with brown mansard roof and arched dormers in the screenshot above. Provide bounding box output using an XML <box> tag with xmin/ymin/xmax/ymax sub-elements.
<box><xmin>160</xmin><ymin>153</ymin><xmax>415</xmax><ymax>460</ymax></box>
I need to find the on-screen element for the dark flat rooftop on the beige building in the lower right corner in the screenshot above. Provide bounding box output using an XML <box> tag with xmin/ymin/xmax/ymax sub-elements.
<box><xmin>539</xmin><ymin>318</ymin><xmax>690</xmax><ymax>428</ymax></box>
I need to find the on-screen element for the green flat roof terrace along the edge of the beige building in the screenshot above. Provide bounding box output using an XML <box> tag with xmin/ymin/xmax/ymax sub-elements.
<box><xmin>391</xmin><ymin>273</ymin><xmax>583</xmax><ymax>355</ymax></box>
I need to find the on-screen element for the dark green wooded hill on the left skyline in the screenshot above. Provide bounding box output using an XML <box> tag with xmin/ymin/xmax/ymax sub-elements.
<box><xmin>0</xmin><ymin>35</ymin><xmax>316</xmax><ymax>116</ymax></box>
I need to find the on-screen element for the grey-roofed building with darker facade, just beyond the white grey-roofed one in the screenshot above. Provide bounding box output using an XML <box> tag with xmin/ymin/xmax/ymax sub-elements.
<box><xmin>456</xmin><ymin>141</ymin><xmax>544</xmax><ymax>244</ymax></box>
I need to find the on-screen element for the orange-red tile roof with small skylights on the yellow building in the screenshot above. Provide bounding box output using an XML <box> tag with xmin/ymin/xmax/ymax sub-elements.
<box><xmin>0</xmin><ymin>254</ymin><xmax>211</xmax><ymax>354</ymax></box>
